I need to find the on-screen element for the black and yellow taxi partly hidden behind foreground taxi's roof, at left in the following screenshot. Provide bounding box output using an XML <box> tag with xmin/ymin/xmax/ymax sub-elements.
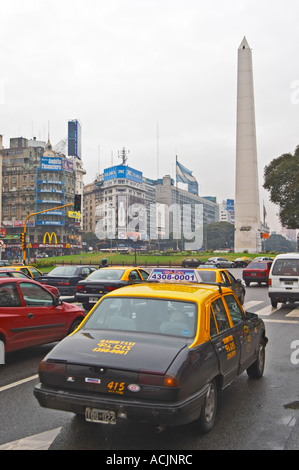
<box><xmin>75</xmin><ymin>267</ymin><xmax>148</xmax><ymax>310</ymax></box>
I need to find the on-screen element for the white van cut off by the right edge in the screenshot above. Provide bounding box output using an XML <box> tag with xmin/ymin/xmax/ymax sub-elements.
<box><xmin>268</xmin><ymin>253</ymin><xmax>299</xmax><ymax>307</ymax></box>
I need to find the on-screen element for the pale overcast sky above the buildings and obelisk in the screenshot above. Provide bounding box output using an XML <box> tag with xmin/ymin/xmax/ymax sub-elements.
<box><xmin>0</xmin><ymin>0</ymin><xmax>299</xmax><ymax>230</ymax></box>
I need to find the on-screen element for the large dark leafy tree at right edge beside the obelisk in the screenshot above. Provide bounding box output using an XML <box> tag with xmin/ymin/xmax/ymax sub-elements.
<box><xmin>264</xmin><ymin>146</ymin><xmax>299</xmax><ymax>229</ymax></box>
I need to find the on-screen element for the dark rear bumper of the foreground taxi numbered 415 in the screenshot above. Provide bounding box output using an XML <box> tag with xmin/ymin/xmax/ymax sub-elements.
<box><xmin>34</xmin><ymin>384</ymin><xmax>208</xmax><ymax>426</ymax></box>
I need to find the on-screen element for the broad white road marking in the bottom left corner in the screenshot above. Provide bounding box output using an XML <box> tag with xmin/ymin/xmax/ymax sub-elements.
<box><xmin>0</xmin><ymin>427</ymin><xmax>61</xmax><ymax>450</ymax></box>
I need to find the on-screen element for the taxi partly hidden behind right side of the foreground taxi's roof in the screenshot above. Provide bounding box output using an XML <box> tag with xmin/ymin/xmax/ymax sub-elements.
<box><xmin>198</xmin><ymin>264</ymin><xmax>246</xmax><ymax>305</ymax></box>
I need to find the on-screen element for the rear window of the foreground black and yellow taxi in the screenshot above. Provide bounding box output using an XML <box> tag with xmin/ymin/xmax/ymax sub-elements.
<box><xmin>83</xmin><ymin>297</ymin><xmax>197</xmax><ymax>338</ymax></box>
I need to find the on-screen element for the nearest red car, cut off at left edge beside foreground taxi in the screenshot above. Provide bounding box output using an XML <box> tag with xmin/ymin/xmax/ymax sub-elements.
<box><xmin>0</xmin><ymin>277</ymin><xmax>85</xmax><ymax>363</ymax></box>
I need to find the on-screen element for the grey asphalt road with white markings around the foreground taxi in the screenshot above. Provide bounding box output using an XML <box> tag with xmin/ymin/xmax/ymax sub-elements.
<box><xmin>0</xmin><ymin>269</ymin><xmax>299</xmax><ymax>454</ymax></box>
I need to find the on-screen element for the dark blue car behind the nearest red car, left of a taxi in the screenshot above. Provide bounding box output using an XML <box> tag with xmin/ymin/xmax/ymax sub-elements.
<box><xmin>38</xmin><ymin>265</ymin><xmax>96</xmax><ymax>296</ymax></box>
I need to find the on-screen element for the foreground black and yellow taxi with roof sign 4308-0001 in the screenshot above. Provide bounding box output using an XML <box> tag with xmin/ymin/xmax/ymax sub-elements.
<box><xmin>34</xmin><ymin>269</ymin><xmax>267</xmax><ymax>432</ymax></box>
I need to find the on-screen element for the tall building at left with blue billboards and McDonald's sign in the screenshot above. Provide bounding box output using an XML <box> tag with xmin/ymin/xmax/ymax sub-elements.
<box><xmin>1</xmin><ymin>137</ymin><xmax>83</xmax><ymax>258</ymax></box>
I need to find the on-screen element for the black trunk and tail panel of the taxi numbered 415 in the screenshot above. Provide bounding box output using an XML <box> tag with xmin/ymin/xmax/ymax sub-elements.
<box><xmin>39</xmin><ymin>330</ymin><xmax>187</xmax><ymax>401</ymax></box>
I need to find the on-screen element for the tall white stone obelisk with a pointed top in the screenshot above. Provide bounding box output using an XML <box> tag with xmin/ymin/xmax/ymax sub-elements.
<box><xmin>235</xmin><ymin>37</ymin><xmax>261</xmax><ymax>253</ymax></box>
